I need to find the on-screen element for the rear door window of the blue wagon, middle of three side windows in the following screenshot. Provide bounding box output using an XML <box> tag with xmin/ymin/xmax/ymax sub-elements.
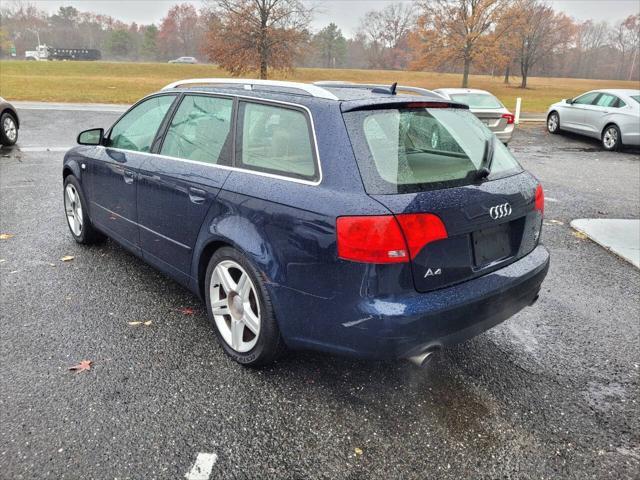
<box><xmin>160</xmin><ymin>95</ymin><xmax>233</xmax><ymax>163</ymax></box>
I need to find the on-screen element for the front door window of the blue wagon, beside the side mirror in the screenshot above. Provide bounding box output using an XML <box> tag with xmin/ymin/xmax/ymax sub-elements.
<box><xmin>109</xmin><ymin>95</ymin><xmax>176</xmax><ymax>152</ymax></box>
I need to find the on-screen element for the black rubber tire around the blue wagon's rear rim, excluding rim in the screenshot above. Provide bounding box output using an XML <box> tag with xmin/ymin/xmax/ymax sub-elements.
<box><xmin>204</xmin><ymin>247</ymin><xmax>286</xmax><ymax>367</ymax></box>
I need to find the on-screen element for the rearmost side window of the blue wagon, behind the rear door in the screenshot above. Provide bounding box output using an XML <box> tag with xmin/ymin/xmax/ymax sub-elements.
<box><xmin>236</xmin><ymin>102</ymin><xmax>318</xmax><ymax>179</ymax></box>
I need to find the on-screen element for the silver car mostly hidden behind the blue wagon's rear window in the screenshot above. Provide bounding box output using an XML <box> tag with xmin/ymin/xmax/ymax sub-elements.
<box><xmin>434</xmin><ymin>88</ymin><xmax>515</xmax><ymax>145</ymax></box>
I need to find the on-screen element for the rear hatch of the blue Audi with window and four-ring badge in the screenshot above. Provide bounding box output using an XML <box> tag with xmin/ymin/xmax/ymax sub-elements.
<box><xmin>344</xmin><ymin>103</ymin><xmax>542</xmax><ymax>292</ymax></box>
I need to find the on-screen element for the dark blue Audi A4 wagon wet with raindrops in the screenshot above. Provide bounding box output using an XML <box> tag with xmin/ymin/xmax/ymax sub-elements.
<box><xmin>63</xmin><ymin>79</ymin><xmax>549</xmax><ymax>365</ymax></box>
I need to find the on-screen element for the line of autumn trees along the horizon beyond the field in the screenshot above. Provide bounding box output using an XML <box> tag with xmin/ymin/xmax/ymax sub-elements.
<box><xmin>0</xmin><ymin>0</ymin><xmax>640</xmax><ymax>88</ymax></box>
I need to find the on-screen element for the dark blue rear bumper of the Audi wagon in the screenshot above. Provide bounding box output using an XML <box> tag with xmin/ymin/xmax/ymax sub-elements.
<box><xmin>286</xmin><ymin>246</ymin><xmax>549</xmax><ymax>359</ymax></box>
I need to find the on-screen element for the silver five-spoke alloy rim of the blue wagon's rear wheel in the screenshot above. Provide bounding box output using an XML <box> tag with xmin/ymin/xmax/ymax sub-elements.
<box><xmin>209</xmin><ymin>260</ymin><xmax>261</xmax><ymax>353</ymax></box>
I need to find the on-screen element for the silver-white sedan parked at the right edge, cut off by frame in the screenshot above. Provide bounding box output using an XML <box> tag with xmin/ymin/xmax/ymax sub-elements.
<box><xmin>547</xmin><ymin>89</ymin><xmax>640</xmax><ymax>150</ymax></box>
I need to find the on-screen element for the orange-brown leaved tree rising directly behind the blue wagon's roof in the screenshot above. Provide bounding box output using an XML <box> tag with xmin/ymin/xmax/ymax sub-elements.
<box><xmin>206</xmin><ymin>0</ymin><xmax>312</xmax><ymax>78</ymax></box>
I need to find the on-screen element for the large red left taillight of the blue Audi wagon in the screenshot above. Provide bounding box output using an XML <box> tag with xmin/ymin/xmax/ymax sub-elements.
<box><xmin>336</xmin><ymin>213</ymin><xmax>447</xmax><ymax>263</ymax></box>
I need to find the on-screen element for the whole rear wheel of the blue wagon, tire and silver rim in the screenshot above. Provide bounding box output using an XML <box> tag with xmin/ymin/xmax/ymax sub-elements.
<box><xmin>205</xmin><ymin>247</ymin><xmax>284</xmax><ymax>367</ymax></box>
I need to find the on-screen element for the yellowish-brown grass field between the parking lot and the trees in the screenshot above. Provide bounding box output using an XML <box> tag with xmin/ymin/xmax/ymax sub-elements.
<box><xmin>0</xmin><ymin>61</ymin><xmax>640</xmax><ymax>112</ymax></box>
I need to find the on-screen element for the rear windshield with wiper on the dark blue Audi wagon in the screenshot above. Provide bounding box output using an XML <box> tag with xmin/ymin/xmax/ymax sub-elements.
<box><xmin>344</xmin><ymin>108</ymin><xmax>522</xmax><ymax>194</ymax></box>
